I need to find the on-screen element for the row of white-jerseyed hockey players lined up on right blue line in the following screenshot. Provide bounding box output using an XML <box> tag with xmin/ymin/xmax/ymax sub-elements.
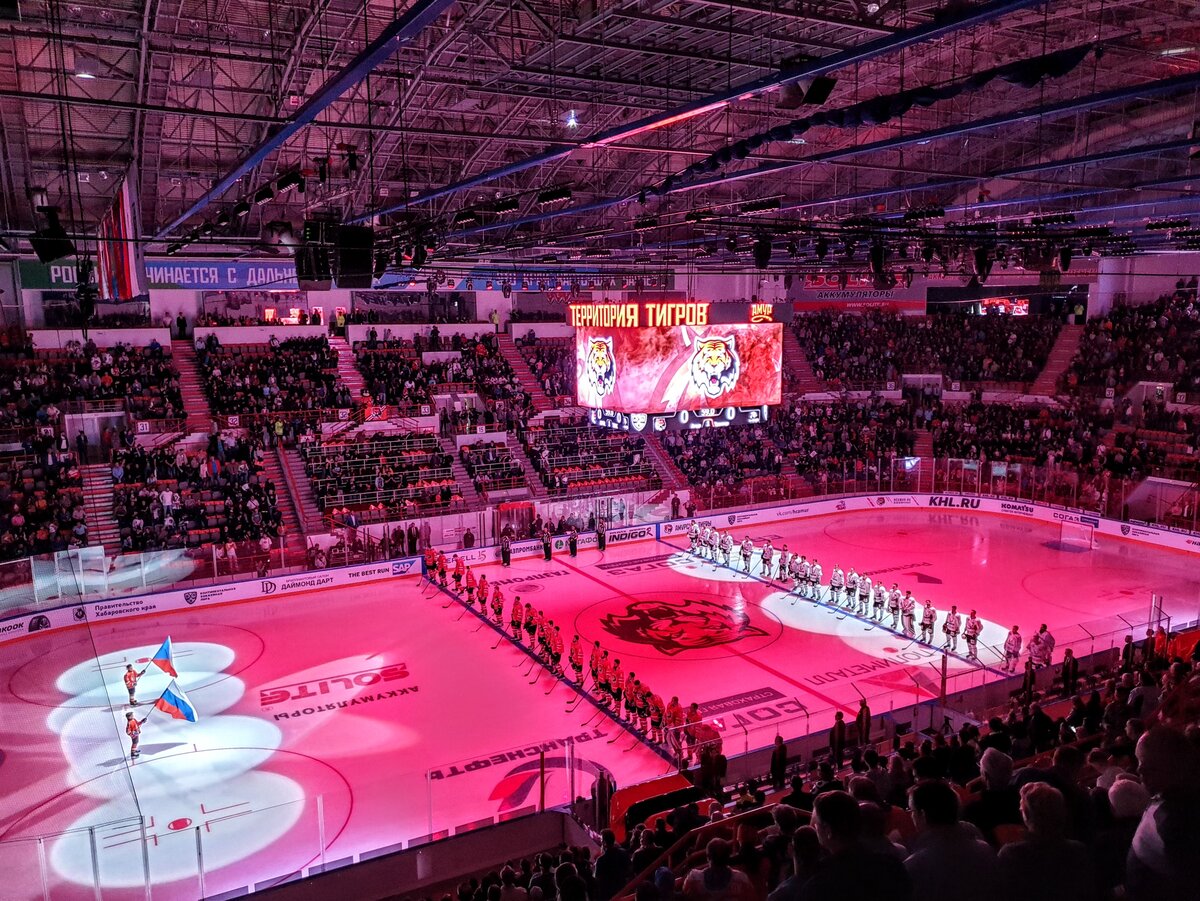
<box><xmin>688</xmin><ymin>519</ymin><xmax>1055</xmax><ymax>672</ymax></box>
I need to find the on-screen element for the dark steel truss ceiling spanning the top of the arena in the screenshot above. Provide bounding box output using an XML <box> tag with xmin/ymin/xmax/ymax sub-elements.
<box><xmin>0</xmin><ymin>0</ymin><xmax>1200</xmax><ymax>271</ymax></box>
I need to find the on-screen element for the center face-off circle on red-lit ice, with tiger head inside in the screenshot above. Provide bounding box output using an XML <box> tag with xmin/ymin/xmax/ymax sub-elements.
<box><xmin>575</xmin><ymin>590</ymin><xmax>782</xmax><ymax>660</ymax></box>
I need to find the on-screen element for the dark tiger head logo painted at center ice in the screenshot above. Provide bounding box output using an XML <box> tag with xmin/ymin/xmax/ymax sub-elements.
<box><xmin>600</xmin><ymin>599</ymin><xmax>767</xmax><ymax>657</ymax></box>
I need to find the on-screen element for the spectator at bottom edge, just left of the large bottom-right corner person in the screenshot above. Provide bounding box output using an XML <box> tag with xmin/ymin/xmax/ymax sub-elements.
<box><xmin>1000</xmin><ymin>782</ymin><xmax>1099</xmax><ymax>901</ymax></box>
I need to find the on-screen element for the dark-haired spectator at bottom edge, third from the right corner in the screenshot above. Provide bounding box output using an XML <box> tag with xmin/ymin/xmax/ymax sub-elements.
<box><xmin>904</xmin><ymin>780</ymin><xmax>998</xmax><ymax>901</ymax></box>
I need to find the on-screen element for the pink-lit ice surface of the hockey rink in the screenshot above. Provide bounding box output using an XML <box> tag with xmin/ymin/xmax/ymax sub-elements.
<box><xmin>0</xmin><ymin>510</ymin><xmax>1200</xmax><ymax>899</ymax></box>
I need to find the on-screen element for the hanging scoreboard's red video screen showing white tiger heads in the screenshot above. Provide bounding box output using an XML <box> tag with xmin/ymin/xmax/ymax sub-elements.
<box><xmin>575</xmin><ymin>309</ymin><xmax>784</xmax><ymax>415</ymax></box>
